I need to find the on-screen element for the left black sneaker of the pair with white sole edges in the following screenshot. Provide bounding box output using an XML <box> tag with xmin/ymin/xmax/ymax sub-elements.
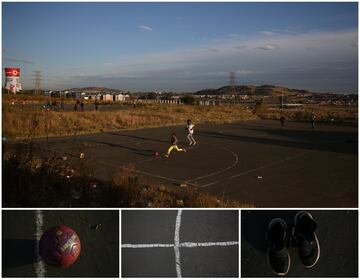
<box><xmin>266</xmin><ymin>218</ymin><xmax>290</xmax><ymax>275</ymax></box>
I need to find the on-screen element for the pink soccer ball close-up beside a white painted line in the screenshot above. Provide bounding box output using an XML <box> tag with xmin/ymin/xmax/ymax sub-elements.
<box><xmin>39</xmin><ymin>225</ymin><xmax>81</xmax><ymax>267</ymax></box>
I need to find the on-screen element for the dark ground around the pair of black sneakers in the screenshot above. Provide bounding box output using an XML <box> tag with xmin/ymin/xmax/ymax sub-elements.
<box><xmin>241</xmin><ymin>210</ymin><xmax>358</xmax><ymax>277</ymax></box>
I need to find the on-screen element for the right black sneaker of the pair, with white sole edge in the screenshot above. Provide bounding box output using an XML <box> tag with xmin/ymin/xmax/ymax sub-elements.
<box><xmin>293</xmin><ymin>211</ymin><xmax>320</xmax><ymax>268</ymax></box>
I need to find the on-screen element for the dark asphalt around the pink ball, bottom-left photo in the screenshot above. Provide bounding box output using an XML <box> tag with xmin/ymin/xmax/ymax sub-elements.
<box><xmin>2</xmin><ymin>210</ymin><xmax>119</xmax><ymax>278</ymax></box>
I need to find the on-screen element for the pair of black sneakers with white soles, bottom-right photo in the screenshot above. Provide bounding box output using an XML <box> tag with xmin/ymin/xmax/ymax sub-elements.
<box><xmin>266</xmin><ymin>211</ymin><xmax>320</xmax><ymax>275</ymax></box>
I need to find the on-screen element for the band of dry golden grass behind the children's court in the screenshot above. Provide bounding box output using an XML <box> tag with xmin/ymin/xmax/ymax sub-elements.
<box><xmin>2</xmin><ymin>101</ymin><xmax>256</xmax><ymax>138</ymax></box>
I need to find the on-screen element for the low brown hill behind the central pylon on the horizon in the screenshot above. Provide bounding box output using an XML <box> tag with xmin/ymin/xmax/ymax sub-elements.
<box><xmin>194</xmin><ymin>85</ymin><xmax>313</xmax><ymax>96</ymax></box>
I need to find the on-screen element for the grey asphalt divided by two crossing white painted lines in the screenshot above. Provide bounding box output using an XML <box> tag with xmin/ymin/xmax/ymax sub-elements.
<box><xmin>121</xmin><ymin>210</ymin><xmax>239</xmax><ymax>277</ymax></box>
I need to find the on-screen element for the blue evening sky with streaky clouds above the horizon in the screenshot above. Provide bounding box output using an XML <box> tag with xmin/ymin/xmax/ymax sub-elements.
<box><xmin>2</xmin><ymin>2</ymin><xmax>358</xmax><ymax>93</ymax></box>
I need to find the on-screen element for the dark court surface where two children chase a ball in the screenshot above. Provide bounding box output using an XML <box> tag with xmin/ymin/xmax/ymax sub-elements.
<box><xmin>31</xmin><ymin>120</ymin><xmax>358</xmax><ymax>208</ymax></box>
